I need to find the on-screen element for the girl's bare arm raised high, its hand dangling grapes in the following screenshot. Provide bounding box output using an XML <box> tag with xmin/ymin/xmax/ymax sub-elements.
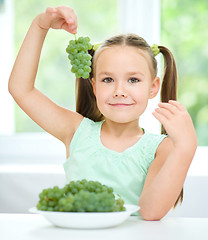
<box><xmin>9</xmin><ymin>7</ymin><xmax>82</xmax><ymax>150</ymax></box>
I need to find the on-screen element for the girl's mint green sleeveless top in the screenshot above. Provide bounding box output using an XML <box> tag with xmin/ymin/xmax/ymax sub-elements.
<box><xmin>64</xmin><ymin>118</ymin><xmax>166</xmax><ymax>213</ymax></box>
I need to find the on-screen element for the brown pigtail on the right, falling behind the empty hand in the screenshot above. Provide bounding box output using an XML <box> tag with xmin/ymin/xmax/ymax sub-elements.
<box><xmin>159</xmin><ymin>46</ymin><xmax>183</xmax><ymax>208</ymax></box>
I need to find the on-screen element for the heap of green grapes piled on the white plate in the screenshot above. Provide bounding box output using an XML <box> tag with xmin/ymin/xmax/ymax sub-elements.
<box><xmin>37</xmin><ymin>179</ymin><xmax>125</xmax><ymax>212</ymax></box>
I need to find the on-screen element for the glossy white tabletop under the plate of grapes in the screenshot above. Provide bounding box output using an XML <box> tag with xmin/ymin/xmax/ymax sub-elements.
<box><xmin>0</xmin><ymin>214</ymin><xmax>208</xmax><ymax>240</ymax></box>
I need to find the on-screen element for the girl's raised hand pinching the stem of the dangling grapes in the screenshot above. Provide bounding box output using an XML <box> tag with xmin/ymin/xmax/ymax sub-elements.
<box><xmin>36</xmin><ymin>6</ymin><xmax>77</xmax><ymax>34</ymax></box>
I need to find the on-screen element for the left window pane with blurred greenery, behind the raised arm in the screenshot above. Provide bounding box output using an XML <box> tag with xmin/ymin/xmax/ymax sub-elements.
<box><xmin>14</xmin><ymin>0</ymin><xmax>119</xmax><ymax>132</ymax></box>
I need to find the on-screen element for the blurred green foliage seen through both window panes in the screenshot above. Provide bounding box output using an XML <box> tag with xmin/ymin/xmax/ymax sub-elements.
<box><xmin>14</xmin><ymin>0</ymin><xmax>208</xmax><ymax>145</ymax></box>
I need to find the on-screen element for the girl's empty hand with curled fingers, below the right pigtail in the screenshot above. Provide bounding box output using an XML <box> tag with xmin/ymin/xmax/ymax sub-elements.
<box><xmin>153</xmin><ymin>100</ymin><xmax>197</xmax><ymax>154</ymax></box>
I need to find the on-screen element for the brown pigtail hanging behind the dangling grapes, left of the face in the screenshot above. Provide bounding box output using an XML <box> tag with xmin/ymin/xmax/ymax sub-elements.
<box><xmin>76</xmin><ymin>49</ymin><xmax>103</xmax><ymax>122</ymax></box>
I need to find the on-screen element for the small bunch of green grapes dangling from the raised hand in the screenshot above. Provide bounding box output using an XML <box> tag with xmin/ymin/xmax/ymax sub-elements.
<box><xmin>66</xmin><ymin>37</ymin><xmax>92</xmax><ymax>79</ymax></box>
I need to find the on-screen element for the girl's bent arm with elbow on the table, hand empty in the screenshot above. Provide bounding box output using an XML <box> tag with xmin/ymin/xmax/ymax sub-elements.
<box><xmin>139</xmin><ymin>101</ymin><xmax>197</xmax><ymax>220</ymax></box>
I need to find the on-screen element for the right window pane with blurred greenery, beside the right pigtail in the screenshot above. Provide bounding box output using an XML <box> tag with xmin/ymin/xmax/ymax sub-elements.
<box><xmin>161</xmin><ymin>0</ymin><xmax>208</xmax><ymax>146</ymax></box>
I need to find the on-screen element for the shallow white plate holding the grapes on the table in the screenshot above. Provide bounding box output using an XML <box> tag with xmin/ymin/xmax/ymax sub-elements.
<box><xmin>29</xmin><ymin>204</ymin><xmax>140</xmax><ymax>229</ymax></box>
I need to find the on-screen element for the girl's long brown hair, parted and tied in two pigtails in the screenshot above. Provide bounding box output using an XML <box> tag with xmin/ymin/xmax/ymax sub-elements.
<box><xmin>76</xmin><ymin>34</ymin><xmax>183</xmax><ymax>208</ymax></box>
